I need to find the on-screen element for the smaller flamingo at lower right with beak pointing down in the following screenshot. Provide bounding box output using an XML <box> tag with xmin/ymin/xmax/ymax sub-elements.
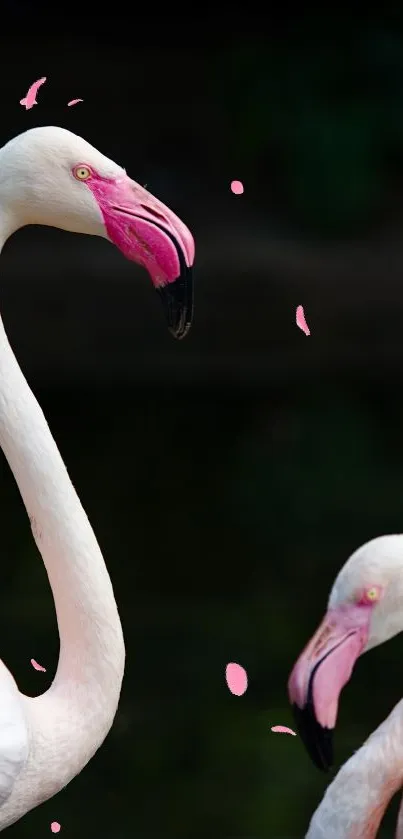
<box><xmin>288</xmin><ymin>534</ymin><xmax>403</xmax><ymax>839</ymax></box>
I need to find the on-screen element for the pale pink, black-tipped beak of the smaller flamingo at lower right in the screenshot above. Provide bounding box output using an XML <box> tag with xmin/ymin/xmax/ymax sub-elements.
<box><xmin>288</xmin><ymin>604</ymin><xmax>369</xmax><ymax>771</ymax></box>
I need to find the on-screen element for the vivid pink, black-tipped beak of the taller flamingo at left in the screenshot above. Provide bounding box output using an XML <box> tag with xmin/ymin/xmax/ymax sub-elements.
<box><xmin>86</xmin><ymin>172</ymin><xmax>195</xmax><ymax>339</ymax></box>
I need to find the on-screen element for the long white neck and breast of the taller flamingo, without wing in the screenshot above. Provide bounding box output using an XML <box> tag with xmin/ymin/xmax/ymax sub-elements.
<box><xmin>0</xmin><ymin>220</ymin><xmax>125</xmax><ymax>829</ymax></box>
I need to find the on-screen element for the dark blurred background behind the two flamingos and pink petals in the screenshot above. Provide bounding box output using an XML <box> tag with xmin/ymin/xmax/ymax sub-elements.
<box><xmin>0</xmin><ymin>8</ymin><xmax>403</xmax><ymax>839</ymax></box>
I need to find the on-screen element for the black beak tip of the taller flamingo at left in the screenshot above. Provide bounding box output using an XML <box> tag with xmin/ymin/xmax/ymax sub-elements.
<box><xmin>158</xmin><ymin>267</ymin><xmax>193</xmax><ymax>341</ymax></box>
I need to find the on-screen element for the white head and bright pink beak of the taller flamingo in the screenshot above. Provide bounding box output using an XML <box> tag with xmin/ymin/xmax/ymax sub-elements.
<box><xmin>0</xmin><ymin>126</ymin><xmax>195</xmax><ymax>338</ymax></box>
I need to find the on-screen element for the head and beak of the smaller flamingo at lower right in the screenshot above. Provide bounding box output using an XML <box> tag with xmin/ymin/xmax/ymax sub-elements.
<box><xmin>288</xmin><ymin>535</ymin><xmax>403</xmax><ymax>771</ymax></box>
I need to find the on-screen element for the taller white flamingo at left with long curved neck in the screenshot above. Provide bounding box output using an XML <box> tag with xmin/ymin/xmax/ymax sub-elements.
<box><xmin>0</xmin><ymin>127</ymin><xmax>194</xmax><ymax>830</ymax></box>
